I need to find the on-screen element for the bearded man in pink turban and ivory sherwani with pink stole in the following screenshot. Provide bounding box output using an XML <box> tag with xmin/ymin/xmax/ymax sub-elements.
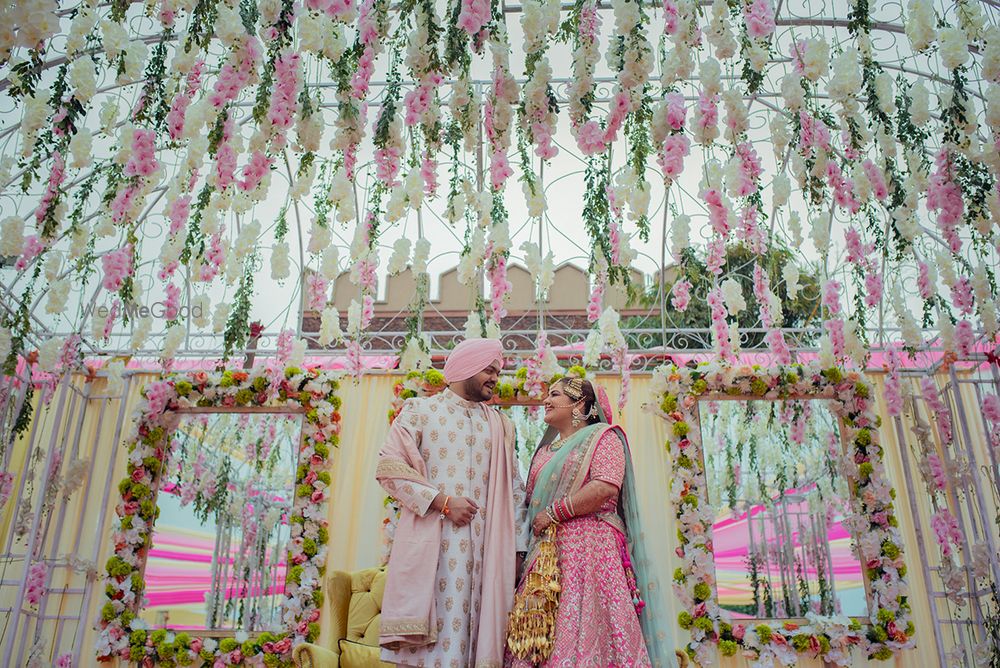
<box><xmin>375</xmin><ymin>339</ymin><xmax>529</xmax><ymax>668</ymax></box>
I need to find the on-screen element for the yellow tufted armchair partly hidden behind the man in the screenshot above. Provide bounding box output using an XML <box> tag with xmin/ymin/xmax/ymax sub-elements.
<box><xmin>292</xmin><ymin>568</ymin><xmax>392</xmax><ymax>668</ymax></box>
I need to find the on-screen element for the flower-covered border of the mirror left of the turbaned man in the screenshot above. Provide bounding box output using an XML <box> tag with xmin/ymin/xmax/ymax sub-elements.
<box><xmin>97</xmin><ymin>367</ymin><xmax>341</xmax><ymax>666</ymax></box>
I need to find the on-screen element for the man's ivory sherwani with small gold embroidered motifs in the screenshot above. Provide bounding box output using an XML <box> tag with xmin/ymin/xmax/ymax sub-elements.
<box><xmin>380</xmin><ymin>390</ymin><xmax>530</xmax><ymax>668</ymax></box>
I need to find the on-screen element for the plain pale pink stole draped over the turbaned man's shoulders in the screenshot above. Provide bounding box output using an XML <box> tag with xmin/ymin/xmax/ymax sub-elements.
<box><xmin>376</xmin><ymin>408</ymin><xmax>515</xmax><ymax>668</ymax></box>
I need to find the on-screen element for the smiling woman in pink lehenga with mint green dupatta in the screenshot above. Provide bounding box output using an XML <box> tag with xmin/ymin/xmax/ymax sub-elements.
<box><xmin>507</xmin><ymin>377</ymin><xmax>673</xmax><ymax>668</ymax></box>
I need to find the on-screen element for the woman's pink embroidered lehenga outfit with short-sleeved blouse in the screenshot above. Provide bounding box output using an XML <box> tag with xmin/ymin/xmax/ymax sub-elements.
<box><xmin>506</xmin><ymin>423</ymin><xmax>651</xmax><ymax>668</ymax></box>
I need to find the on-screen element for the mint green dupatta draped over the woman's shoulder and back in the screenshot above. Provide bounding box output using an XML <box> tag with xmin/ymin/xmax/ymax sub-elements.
<box><xmin>525</xmin><ymin>426</ymin><xmax>676</xmax><ymax>666</ymax></box>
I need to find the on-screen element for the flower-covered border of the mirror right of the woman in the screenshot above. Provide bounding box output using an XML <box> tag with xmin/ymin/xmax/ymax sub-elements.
<box><xmin>647</xmin><ymin>361</ymin><xmax>914</xmax><ymax>666</ymax></box>
